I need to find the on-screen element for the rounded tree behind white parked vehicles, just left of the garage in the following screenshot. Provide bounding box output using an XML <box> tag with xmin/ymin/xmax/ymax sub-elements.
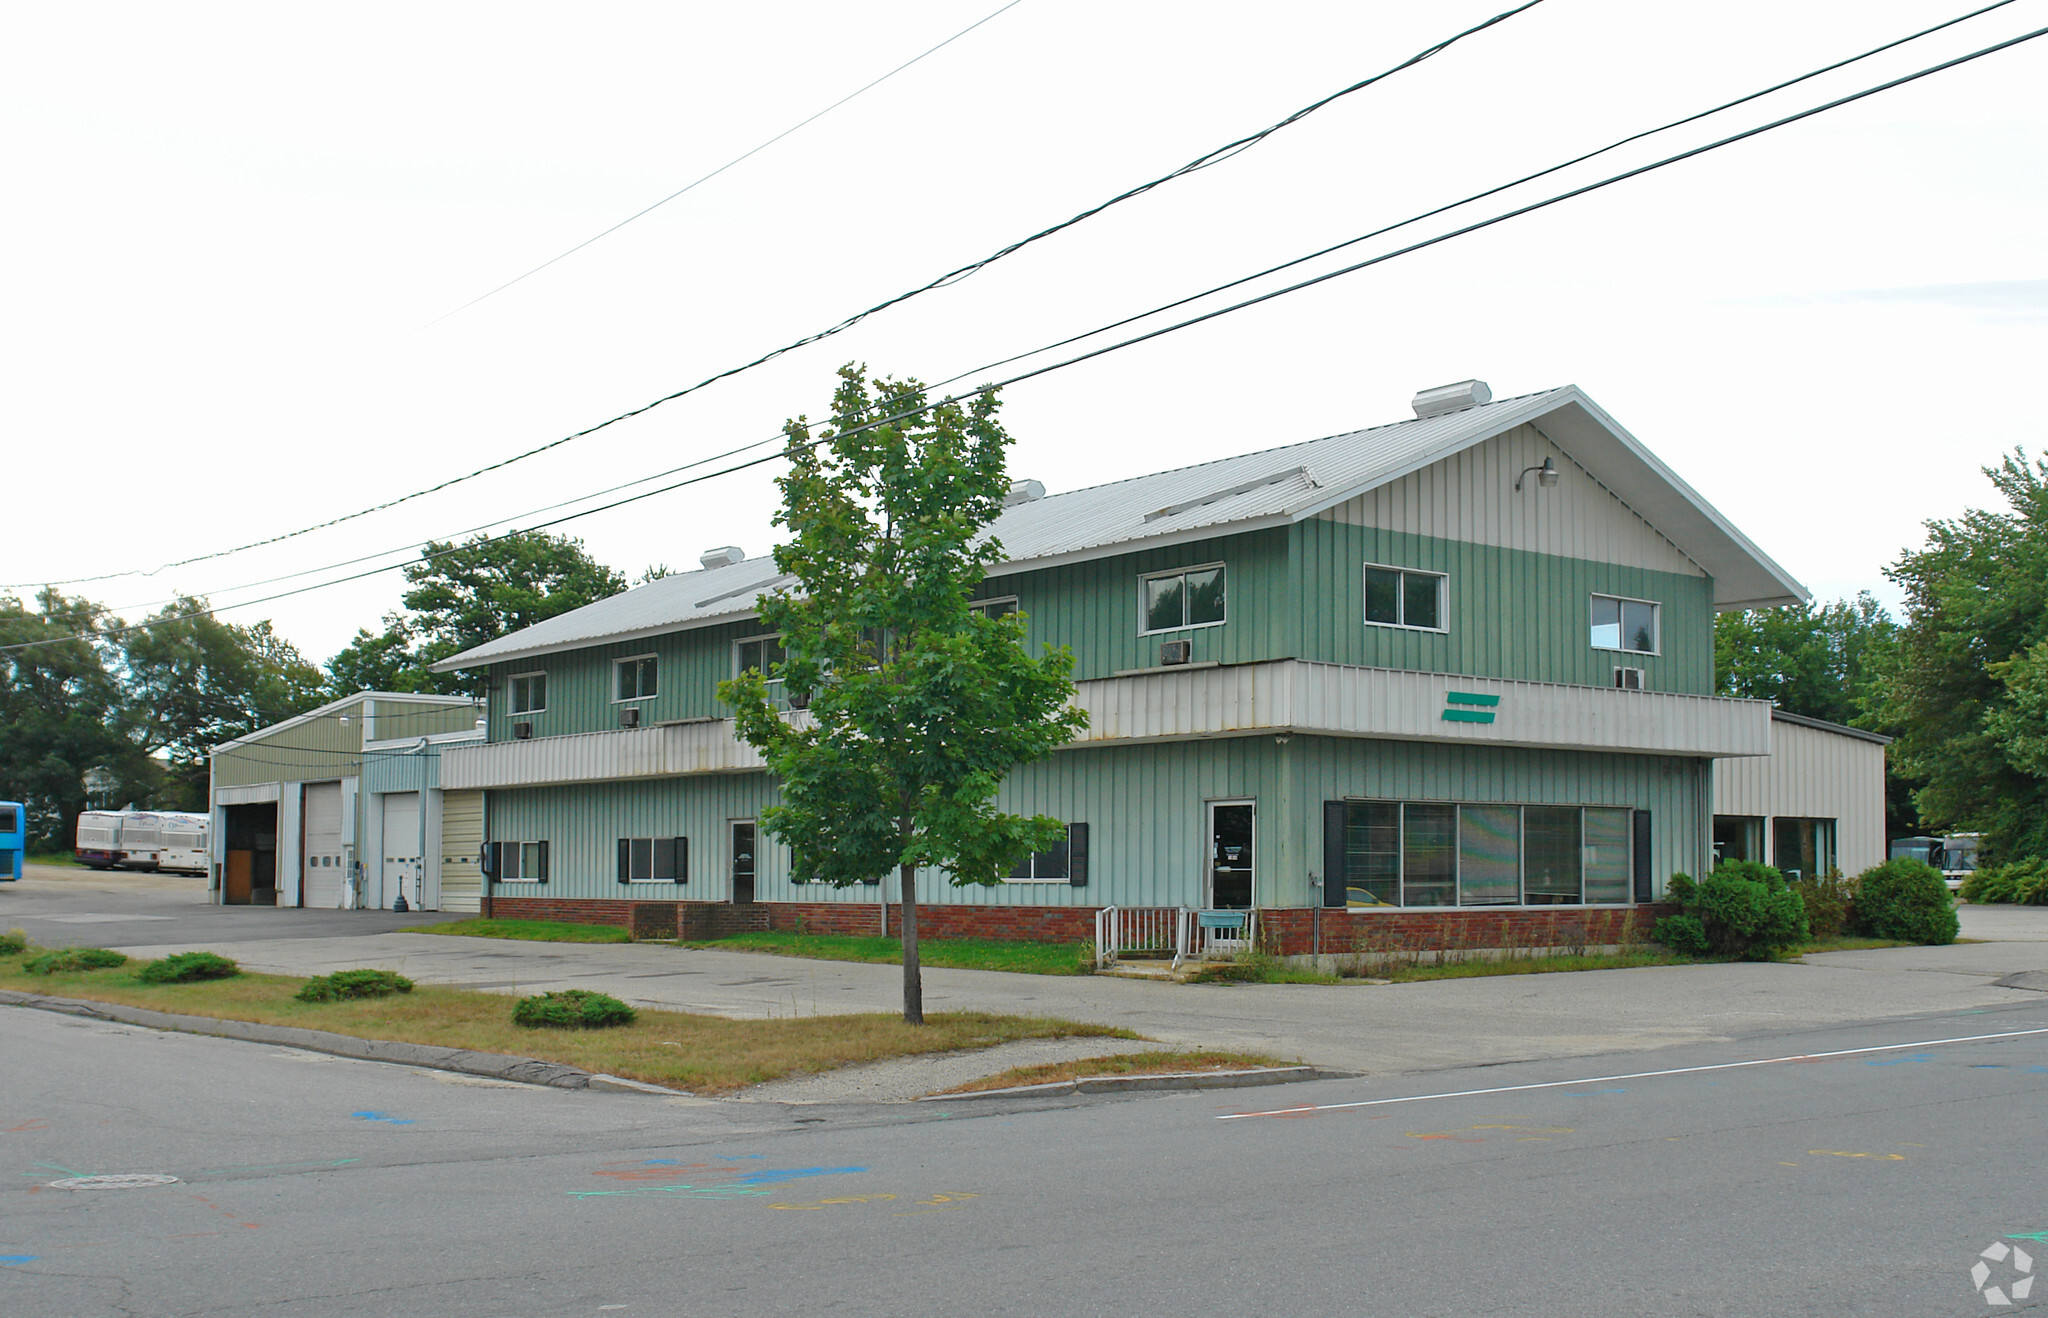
<box><xmin>123</xmin><ymin>598</ymin><xmax>326</xmax><ymax>810</ymax></box>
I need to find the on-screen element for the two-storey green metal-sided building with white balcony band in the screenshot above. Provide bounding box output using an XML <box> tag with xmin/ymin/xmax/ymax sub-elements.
<box><xmin>440</xmin><ymin>381</ymin><xmax>1806</xmax><ymax>950</ymax></box>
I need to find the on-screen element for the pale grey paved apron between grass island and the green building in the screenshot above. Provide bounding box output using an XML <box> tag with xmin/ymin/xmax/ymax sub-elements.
<box><xmin>108</xmin><ymin>907</ymin><xmax>2048</xmax><ymax>1074</ymax></box>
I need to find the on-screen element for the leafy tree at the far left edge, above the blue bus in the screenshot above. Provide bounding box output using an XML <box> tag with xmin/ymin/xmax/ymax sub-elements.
<box><xmin>0</xmin><ymin>589</ymin><xmax>158</xmax><ymax>851</ymax></box>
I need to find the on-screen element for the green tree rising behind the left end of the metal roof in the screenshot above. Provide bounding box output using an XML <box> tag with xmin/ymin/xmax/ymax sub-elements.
<box><xmin>328</xmin><ymin>530</ymin><xmax>627</xmax><ymax>696</ymax></box>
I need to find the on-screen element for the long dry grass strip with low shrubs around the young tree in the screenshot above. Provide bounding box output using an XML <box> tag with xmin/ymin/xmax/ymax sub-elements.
<box><xmin>0</xmin><ymin>958</ymin><xmax>1139</xmax><ymax>1095</ymax></box>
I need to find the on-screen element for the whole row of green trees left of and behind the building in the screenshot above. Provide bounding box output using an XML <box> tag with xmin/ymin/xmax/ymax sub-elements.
<box><xmin>0</xmin><ymin>532</ymin><xmax>622</xmax><ymax>851</ymax></box>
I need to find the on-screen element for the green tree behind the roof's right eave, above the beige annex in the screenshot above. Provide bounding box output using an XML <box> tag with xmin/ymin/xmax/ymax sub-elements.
<box><xmin>1714</xmin><ymin>591</ymin><xmax>1921</xmax><ymax>837</ymax></box>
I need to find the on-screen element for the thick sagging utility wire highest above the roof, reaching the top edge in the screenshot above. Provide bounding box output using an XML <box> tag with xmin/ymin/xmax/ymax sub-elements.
<box><xmin>0</xmin><ymin>0</ymin><xmax>1542</xmax><ymax>589</ymax></box>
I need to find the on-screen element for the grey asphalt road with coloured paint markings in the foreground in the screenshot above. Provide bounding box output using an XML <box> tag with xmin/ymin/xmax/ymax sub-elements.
<box><xmin>0</xmin><ymin>999</ymin><xmax>2048</xmax><ymax>1318</ymax></box>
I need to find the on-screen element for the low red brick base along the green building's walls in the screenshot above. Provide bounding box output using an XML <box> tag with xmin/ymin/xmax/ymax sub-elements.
<box><xmin>492</xmin><ymin>894</ymin><xmax>1675</xmax><ymax>956</ymax></box>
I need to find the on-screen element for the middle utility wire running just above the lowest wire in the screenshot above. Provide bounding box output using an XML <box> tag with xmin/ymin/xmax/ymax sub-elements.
<box><xmin>83</xmin><ymin>0</ymin><xmax>2015</xmax><ymax>614</ymax></box>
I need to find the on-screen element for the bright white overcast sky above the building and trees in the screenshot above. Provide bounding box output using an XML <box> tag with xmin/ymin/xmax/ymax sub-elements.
<box><xmin>0</xmin><ymin>0</ymin><xmax>2048</xmax><ymax>661</ymax></box>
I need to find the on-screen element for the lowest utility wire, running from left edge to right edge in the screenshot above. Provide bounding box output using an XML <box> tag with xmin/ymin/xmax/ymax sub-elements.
<box><xmin>0</xmin><ymin>27</ymin><xmax>2048</xmax><ymax>653</ymax></box>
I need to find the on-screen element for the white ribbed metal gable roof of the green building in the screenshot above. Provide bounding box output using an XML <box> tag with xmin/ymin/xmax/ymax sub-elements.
<box><xmin>434</xmin><ymin>385</ymin><xmax>1808</xmax><ymax>671</ymax></box>
